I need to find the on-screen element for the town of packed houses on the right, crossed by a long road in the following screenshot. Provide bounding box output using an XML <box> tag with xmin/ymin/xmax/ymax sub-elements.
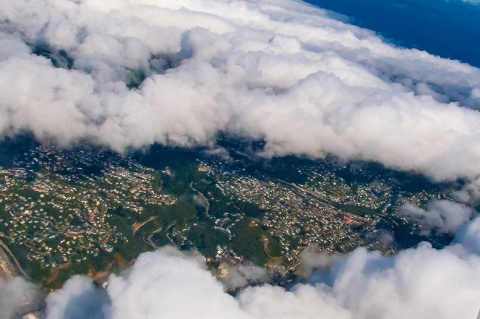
<box><xmin>195</xmin><ymin>161</ymin><xmax>447</xmax><ymax>270</ymax></box>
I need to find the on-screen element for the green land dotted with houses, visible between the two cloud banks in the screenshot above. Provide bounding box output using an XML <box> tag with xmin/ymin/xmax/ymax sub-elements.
<box><xmin>0</xmin><ymin>138</ymin><xmax>458</xmax><ymax>288</ymax></box>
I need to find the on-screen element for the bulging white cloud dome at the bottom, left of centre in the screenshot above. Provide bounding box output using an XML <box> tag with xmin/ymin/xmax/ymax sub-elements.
<box><xmin>47</xmin><ymin>247</ymin><xmax>248</xmax><ymax>319</ymax></box>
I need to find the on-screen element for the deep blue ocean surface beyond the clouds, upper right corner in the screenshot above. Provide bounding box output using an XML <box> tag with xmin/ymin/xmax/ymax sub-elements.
<box><xmin>306</xmin><ymin>0</ymin><xmax>480</xmax><ymax>67</ymax></box>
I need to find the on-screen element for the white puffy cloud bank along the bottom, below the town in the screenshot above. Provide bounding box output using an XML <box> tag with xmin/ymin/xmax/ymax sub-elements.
<box><xmin>47</xmin><ymin>218</ymin><xmax>480</xmax><ymax>319</ymax></box>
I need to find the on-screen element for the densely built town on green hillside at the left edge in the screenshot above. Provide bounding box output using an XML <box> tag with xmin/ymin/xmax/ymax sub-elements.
<box><xmin>0</xmin><ymin>146</ymin><xmax>176</xmax><ymax>267</ymax></box>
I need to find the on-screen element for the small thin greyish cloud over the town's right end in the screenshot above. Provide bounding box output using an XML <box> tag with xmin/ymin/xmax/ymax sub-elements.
<box><xmin>399</xmin><ymin>200</ymin><xmax>477</xmax><ymax>235</ymax></box>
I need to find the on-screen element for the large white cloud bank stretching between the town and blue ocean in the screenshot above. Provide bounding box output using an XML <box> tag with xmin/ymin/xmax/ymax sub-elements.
<box><xmin>0</xmin><ymin>0</ymin><xmax>480</xmax><ymax>180</ymax></box>
